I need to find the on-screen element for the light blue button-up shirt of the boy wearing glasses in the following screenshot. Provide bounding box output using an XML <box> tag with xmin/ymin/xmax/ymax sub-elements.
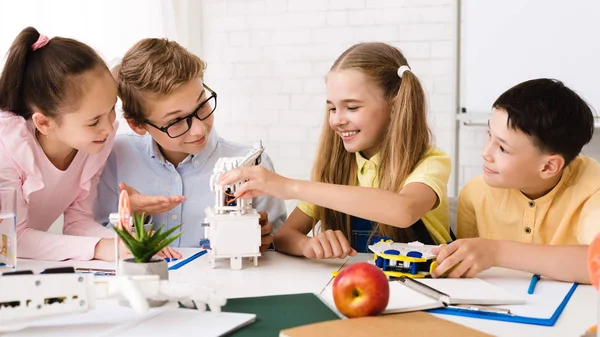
<box><xmin>94</xmin><ymin>128</ymin><xmax>287</xmax><ymax>247</ymax></box>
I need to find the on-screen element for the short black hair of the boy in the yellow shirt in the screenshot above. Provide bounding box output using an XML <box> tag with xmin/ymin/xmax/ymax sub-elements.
<box><xmin>493</xmin><ymin>78</ymin><xmax>594</xmax><ymax>166</ymax></box>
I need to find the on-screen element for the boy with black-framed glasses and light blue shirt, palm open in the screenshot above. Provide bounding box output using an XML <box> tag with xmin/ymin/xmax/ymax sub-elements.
<box><xmin>95</xmin><ymin>38</ymin><xmax>287</xmax><ymax>250</ymax></box>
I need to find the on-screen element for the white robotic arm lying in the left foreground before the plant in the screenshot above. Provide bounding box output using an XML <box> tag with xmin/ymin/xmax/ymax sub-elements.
<box><xmin>0</xmin><ymin>272</ymin><xmax>226</xmax><ymax>334</ymax></box>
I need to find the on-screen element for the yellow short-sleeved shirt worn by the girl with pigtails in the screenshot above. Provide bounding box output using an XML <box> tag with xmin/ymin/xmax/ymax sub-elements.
<box><xmin>298</xmin><ymin>148</ymin><xmax>451</xmax><ymax>244</ymax></box>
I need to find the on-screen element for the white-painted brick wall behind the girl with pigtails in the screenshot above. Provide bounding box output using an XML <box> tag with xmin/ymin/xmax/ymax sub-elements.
<box><xmin>199</xmin><ymin>0</ymin><xmax>457</xmax><ymax>194</ymax></box>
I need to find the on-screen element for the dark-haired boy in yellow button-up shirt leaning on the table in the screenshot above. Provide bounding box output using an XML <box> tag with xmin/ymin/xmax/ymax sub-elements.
<box><xmin>434</xmin><ymin>79</ymin><xmax>600</xmax><ymax>283</ymax></box>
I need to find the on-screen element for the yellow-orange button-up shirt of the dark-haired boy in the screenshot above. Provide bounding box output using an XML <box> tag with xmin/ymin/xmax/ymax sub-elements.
<box><xmin>457</xmin><ymin>156</ymin><xmax>600</xmax><ymax>245</ymax></box>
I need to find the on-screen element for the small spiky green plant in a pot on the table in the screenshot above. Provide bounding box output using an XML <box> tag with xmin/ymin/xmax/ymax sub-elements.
<box><xmin>113</xmin><ymin>213</ymin><xmax>182</xmax><ymax>307</ymax></box>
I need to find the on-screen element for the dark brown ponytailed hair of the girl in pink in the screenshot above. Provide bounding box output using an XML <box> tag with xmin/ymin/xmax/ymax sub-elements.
<box><xmin>0</xmin><ymin>27</ymin><xmax>108</xmax><ymax>119</ymax></box>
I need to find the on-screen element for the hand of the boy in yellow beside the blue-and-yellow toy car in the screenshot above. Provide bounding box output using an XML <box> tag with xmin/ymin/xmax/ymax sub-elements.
<box><xmin>432</xmin><ymin>238</ymin><xmax>498</xmax><ymax>278</ymax></box>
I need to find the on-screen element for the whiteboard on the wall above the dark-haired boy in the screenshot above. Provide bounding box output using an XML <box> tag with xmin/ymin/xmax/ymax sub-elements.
<box><xmin>460</xmin><ymin>0</ymin><xmax>600</xmax><ymax>113</ymax></box>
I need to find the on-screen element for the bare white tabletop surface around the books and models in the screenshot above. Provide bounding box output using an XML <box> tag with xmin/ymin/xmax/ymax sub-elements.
<box><xmin>8</xmin><ymin>249</ymin><xmax>598</xmax><ymax>337</ymax></box>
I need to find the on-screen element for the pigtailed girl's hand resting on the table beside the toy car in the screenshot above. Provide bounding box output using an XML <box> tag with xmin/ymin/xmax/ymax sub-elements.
<box><xmin>302</xmin><ymin>229</ymin><xmax>356</xmax><ymax>259</ymax></box>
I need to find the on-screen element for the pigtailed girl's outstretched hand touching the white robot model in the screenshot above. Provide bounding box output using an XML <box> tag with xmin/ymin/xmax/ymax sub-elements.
<box><xmin>219</xmin><ymin>166</ymin><xmax>291</xmax><ymax>199</ymax></box>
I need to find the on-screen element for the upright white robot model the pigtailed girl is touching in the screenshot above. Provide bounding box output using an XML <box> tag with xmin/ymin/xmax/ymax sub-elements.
<box><xmin>205</xmin><ymin>143</ymin><xmax>264</xmax><ymax>270</ymax></box>
